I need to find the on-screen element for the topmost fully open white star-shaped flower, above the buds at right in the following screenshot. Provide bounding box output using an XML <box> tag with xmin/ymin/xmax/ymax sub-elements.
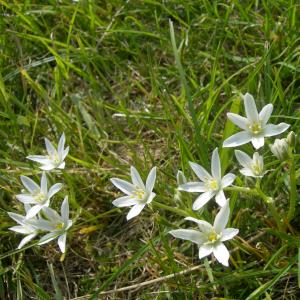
<box><xmin>223</xmin><ymin>93</ymin><xmax>290</xmax><ymax>149</ymax></box>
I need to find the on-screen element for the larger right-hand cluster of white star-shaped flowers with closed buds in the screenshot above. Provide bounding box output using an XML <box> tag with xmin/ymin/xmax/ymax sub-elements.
<box><xmin>111</xmin><ymin>93</ymin><xmax>292</xmax><ymax>266</ymax></box>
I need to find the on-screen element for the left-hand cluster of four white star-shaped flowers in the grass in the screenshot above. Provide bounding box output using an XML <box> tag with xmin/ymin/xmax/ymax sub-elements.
<box><xmin>8</xmin><ymin>133</ymin><xmax>72</xmax><ymax>253</ymax></box>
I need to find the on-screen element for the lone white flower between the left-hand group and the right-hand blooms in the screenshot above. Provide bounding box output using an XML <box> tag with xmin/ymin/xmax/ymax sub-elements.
<box><xmin>111</xmin><ymin>166</ymin><xmax>156</xmax><ymax>220</ymax></box>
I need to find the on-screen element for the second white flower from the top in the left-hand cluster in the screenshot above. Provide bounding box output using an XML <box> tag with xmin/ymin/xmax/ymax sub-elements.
<box><xmin>16</xmin><ymin>172</ymin><xmax>62</xmax><ymax>219</ymax></box>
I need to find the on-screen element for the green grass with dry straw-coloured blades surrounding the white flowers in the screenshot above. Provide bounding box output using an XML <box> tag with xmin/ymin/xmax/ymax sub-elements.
<box><xmin>0</xmin><ymin>0</ymin><xmax>300</xmax><ymax>299</ymax></box>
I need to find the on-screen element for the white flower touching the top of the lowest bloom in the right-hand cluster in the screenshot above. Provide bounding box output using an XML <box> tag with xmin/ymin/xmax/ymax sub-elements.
<box><xmin>179</xmin><ymin>148</ymin><xmax>236</xmax><ymax>210</ymax></box>
